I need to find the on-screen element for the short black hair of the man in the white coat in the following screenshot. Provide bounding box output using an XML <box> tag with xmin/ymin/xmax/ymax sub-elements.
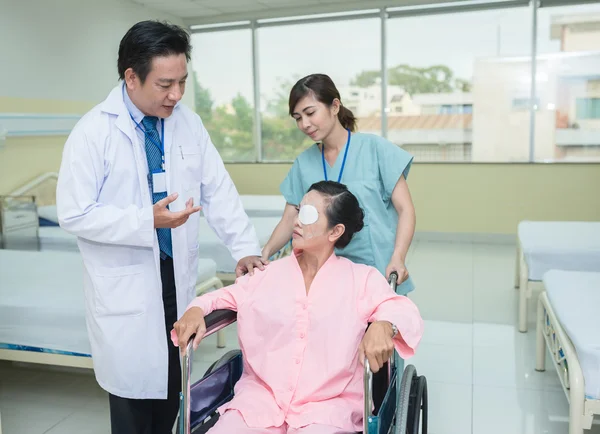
<box><xmin>117</xmin><ymin>20</ymin><xmax>192</xmax><ymax>84</ymax></box>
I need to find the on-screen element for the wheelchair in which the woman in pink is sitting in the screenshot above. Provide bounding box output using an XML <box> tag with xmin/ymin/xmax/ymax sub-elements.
<box><xmin>177</xmin><ymin>276</ymin><xmax>427</xmax><ymax>434</ymax></box>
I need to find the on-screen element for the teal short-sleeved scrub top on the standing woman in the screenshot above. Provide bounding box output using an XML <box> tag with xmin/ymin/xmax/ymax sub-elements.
<box><xmin>280</xmin><ymin>133</ymin><xmax>414</xmax><ymax>295</ymax></box>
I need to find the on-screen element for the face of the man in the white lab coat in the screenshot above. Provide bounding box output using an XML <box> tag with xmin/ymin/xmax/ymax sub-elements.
<box><xmin>125</xmin><ymin>54</ymin><xmax>188</xmax><ymax>118</ymax></box>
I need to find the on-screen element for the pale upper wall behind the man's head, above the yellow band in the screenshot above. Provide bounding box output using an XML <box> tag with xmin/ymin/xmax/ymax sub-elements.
<box><xmin>0</xmin><ymin>0</ymin><xmax>194</xmax><ymax>105</ymax></box>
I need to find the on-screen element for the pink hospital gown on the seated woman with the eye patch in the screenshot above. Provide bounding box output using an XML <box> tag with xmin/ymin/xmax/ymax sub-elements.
<box><xmin>174</xmin><ymin>254</ymin><xmax>423</xmax><ymax>431</ymax></box>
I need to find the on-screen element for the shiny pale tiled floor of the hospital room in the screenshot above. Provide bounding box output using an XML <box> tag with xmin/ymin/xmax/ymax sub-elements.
<box><xmin>0</xmin><ymin>241</ymin><xmax>600</xmax><ymax>434</ymax></box>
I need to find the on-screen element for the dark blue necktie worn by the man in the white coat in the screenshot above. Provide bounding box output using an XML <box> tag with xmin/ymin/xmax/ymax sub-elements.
<box><xmin>142</xmin><ymin>116</ymin><xmax>173</xmax><ymax>259</ymax></box>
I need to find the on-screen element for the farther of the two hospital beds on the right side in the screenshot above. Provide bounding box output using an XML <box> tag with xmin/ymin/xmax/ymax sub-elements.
<box><xmin>515</xmin><ymin>221</ymin><xmax>600</xmax><ymax>332</ymax></box>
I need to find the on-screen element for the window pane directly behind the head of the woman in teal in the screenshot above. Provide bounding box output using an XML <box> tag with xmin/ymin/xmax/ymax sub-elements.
<box><xmin>258</xmin><ymin>18</ymin><xmax>381</xmax><ymax>161</ymax></box>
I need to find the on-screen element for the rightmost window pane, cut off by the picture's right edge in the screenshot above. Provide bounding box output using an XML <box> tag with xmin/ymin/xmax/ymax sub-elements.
<box><xmin>534</xmin><ymin>4</ymin><xmax>600</xmax><ymax>161</ymax></box>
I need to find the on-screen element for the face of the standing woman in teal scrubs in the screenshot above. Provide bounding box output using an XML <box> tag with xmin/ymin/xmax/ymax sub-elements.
<box><xmin>292</xmin><ymin>92</ymin><xmax>339</xmax><ymax>142</ymax></box>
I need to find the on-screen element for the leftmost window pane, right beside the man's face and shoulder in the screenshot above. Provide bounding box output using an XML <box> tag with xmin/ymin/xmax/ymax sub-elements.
<box><xmin>192</xmin><ymin>29</ymin><xmax>256</xmax><ymax>161</ymax></box>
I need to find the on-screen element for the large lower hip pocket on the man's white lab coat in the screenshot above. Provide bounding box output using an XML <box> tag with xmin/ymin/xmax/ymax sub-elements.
<box><xmin>94</xmin><ymin>264</ymin><xmax>151</xmax><ymax>316</ymax></box>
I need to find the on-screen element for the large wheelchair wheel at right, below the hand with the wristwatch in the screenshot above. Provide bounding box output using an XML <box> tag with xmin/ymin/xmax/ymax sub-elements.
<box><xmin>396</xmin><ymin>365</ymin><xmax>427</xmax><ymax>434</ymax></box>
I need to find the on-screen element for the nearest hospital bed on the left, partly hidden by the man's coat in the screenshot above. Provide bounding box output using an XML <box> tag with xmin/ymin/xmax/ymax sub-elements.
<box><xmin>0</xmin><ymin>250</ymin><xmax>225</xmax><ymax>368</ymax></box>
